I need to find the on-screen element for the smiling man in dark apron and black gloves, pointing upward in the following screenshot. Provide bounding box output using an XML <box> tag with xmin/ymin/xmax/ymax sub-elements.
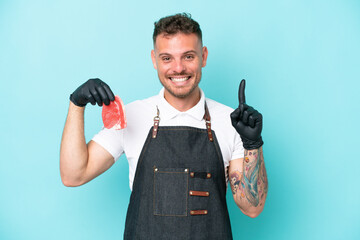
<box><xmin>60</xmin><ymin>14</ymin><xmax>267</xmax><ymax>239</ymax></box>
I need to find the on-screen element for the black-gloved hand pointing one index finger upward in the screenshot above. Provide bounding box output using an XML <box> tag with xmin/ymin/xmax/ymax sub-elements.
<box><xmin>230</xmin><ymin>79</ymin><xmax>264</xmax><ymax>150</ymax></box>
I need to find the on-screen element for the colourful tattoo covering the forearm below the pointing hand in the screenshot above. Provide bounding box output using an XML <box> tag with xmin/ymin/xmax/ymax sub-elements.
<box><xmin>230</xmin><ymin>149</ymin><xmax>268</xmax><ymax>207</ymax></box>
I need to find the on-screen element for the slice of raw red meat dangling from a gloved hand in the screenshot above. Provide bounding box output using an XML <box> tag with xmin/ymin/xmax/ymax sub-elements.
<box><xmin>102</xmin><ymin>96</ymin><xmax>126</xmax><ymax>130</ymax></box>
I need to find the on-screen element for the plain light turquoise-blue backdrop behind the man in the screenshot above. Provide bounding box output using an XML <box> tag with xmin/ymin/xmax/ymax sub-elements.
<box><xmin>0</xmin><ymin>0</ymin><xmax>360</xmax><ymax>240</ymax></box>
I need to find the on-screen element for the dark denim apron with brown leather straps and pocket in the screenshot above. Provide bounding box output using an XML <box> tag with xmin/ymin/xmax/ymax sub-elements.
<box><xmin>124</xmin><ymin>104</ymin><xmax>232</xmax><ymax>240</ymax></box>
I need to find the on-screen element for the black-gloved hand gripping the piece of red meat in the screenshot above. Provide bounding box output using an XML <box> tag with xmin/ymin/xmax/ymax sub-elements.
<box><xmin>70</xmin><ymin>78</ymin><xmax>115</xmax><ymax>107</ymax></box>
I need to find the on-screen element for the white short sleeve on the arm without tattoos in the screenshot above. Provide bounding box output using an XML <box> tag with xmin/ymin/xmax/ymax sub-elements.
<box><xmin>92</xmin><ymin>128</ymin><xmax>124</xmax><ymax>161</ymax></box>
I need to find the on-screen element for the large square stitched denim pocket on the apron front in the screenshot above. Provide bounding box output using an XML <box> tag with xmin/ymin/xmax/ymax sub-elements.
<box><xmin>154</xmin><ymin>167</ymin><xmax>189</xmax><ymax>216</ymax></box>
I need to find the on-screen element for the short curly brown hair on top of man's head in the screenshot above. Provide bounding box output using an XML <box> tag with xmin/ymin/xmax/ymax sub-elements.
<box><xmin>153</xmin><ymin>13</ymin><xmax>202</xmax><ymax>44</ymax></box>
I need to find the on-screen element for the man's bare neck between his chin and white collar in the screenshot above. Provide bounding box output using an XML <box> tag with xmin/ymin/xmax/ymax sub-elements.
<box><xmin>164</xmin><ymin>88</ymin><xmax>201</xmax><ymax>112</ymax></box>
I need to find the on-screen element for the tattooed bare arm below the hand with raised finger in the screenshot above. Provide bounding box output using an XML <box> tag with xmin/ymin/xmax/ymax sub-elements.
<box><xmin>229</xmin><ymin>147</ymin><xmax>268</xmax><ymax>218</ymax></box>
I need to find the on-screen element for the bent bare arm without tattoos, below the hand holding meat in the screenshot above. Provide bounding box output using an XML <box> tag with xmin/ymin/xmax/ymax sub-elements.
<box><xmin>60</xmin><ymin>102</ymin><xmax>114</xmax><ymax>187</ymax></box>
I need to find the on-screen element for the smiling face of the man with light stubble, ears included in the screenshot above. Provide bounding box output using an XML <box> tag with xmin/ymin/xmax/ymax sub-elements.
<box><xmin>151</xmin><ymin>33</ymin><xmax>208</xmax><ymax>99</ymax></box>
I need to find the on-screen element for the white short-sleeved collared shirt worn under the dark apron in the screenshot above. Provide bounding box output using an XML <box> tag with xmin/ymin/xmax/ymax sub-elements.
<box><xmin>92</xmin><ymin>88</ymin><xmax>244</xmax><ymax>190</ymax></box>
